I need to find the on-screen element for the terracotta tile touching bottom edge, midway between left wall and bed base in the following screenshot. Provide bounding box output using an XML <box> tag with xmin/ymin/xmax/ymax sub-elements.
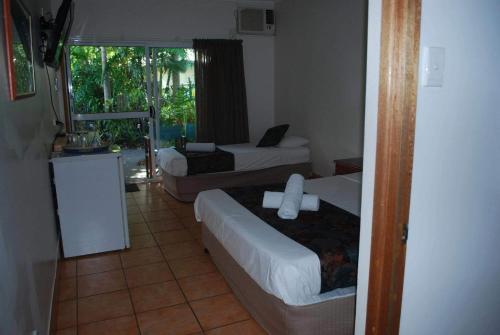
<box><xmin>137</xmin><ymin>304</ymin><xmax>201</xmax><ymax>335</ymax></box>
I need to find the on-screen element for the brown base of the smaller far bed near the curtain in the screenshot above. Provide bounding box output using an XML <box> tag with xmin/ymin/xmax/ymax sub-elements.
<box><xmin>162</xmin><ymin>163</ymin><xmax>312</xmax><ymax>202</ymax></box>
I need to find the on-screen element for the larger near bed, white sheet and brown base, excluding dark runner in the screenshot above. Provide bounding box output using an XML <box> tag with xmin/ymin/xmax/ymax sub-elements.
<box><xmin>194</xmin><ymin>173</ymin><xmax>361</xmax><ymax>334</ymax></box>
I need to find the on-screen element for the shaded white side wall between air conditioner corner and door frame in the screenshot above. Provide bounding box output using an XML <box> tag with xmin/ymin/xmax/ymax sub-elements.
<box><xmin>275</xmin><ymin>0</ymin><xmax>367</xmax><ymax>175</ymax></box>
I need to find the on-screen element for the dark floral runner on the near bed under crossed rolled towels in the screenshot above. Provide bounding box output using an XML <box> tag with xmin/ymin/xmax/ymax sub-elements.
<box><xmin>224</xmin><ymin>185</ymin><xmax>359</xmax><ymax>293</ymax></box>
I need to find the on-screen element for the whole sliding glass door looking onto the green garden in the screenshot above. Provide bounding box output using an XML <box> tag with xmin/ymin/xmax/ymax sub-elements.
<box><xmin>67</xmin><ymin>45</ymin><xmax>196</xmax><ymax>178</ymax></box>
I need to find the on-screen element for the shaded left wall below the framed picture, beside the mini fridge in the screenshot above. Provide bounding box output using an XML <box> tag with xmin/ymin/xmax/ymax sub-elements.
<box><xmin>0</xmin><ymin>0</ymin><xmax>58</xmax><ymax>334</ymax></box>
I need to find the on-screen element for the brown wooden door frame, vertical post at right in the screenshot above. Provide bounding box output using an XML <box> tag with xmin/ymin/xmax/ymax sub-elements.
<box><xmin>365</xmin><ymin>0</ymin><xmax>421</xmax><ymax>335</ymax></box>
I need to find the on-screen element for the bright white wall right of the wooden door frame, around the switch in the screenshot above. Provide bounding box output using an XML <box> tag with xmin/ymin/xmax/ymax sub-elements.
<box><xmin>400</xmin><ymin>0</ymin><xmax>500</xmax><ymax>334</ymax></box>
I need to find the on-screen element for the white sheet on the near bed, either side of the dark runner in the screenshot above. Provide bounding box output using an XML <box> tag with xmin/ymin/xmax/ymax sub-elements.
<box><xmin>194</xmin><ymin>176</ymin><xmax>361</xmax><ymax>306</ymax></box>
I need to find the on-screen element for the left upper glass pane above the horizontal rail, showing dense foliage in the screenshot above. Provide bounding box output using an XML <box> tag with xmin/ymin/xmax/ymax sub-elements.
<box><xmin>69</xmin><ymin>46</ymin><xmax>148</xmax><ymax>114</ymax></box>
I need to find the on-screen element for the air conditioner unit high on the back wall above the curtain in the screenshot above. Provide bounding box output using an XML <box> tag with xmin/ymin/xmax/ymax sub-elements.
<box><xmin>237</xmin><ymin>8</ymin><xmax>276</xmax><ymax>35</ymax></box>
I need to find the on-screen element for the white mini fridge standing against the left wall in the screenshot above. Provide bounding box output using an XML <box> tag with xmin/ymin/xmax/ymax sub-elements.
<box><xmin>51</xmin><ymin>153</ymin><xmax>130</xmax><ymax>257</ymax></box>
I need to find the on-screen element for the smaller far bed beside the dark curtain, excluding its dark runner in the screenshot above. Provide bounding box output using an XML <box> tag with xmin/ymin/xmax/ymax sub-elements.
<box><xmin>156</xmin><ymin>143</ymin><xmax>311</xmax><ymax>201</ymax></box>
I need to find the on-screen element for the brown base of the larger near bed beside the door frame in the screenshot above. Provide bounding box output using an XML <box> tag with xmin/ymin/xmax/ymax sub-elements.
<box><xmin>202</xmin><ymin>224</ymin><xmax>355</xmax><ymax>335</ymax></box>
